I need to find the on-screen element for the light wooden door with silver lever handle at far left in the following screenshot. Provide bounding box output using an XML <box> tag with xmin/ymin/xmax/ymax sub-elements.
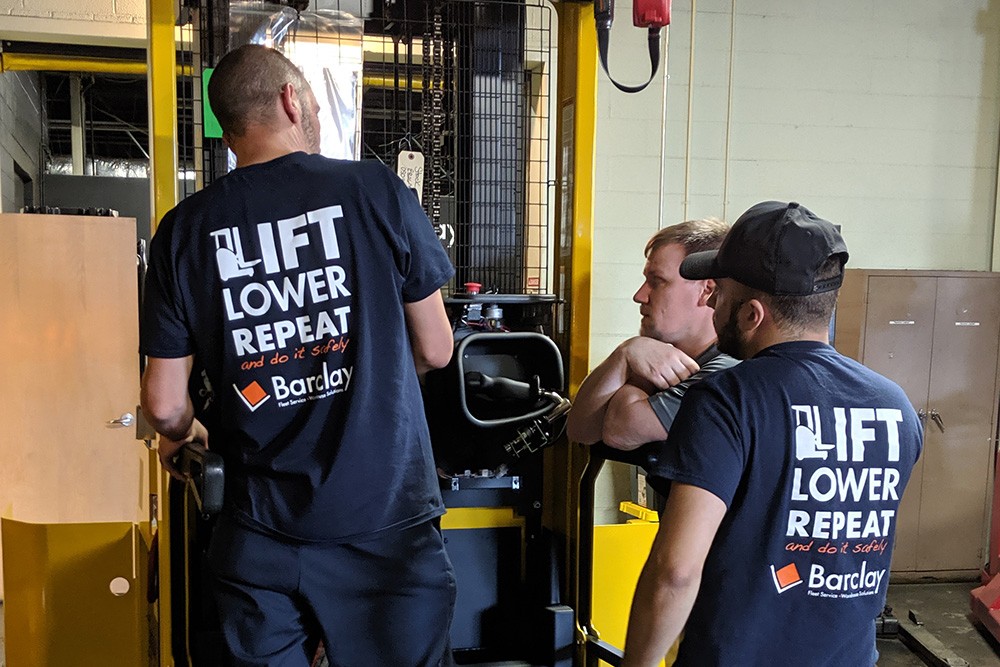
<box><xmin>0</xmin><ymin>215</ymin><xmax>149</xmax><ymax>595</ymax></box>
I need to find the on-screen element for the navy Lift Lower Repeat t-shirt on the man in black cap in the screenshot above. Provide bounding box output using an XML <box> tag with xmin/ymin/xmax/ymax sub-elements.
<box><xmin>651</xmin><ymin>341</ymin><xmax>922</xmax><ymax>666</ymax></box>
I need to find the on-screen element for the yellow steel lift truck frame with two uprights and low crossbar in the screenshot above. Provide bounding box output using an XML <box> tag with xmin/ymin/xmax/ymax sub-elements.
<box><xmin>147</xmin><ymin>0</ymin><xmax>597</xmax><ymax>667</ymax></box>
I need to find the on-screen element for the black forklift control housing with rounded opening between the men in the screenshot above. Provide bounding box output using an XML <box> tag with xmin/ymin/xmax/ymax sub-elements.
<box><xmin>424</xmin><ymin>294</ymin><xmax>573</xmax><ymax>665</ymax></box>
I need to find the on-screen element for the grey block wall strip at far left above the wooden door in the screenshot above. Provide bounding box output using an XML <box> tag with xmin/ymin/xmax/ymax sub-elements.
<box><xmin>0</xmin><ymin>72</ymin><xmax>42</xmax><ymax>213</ymax></box>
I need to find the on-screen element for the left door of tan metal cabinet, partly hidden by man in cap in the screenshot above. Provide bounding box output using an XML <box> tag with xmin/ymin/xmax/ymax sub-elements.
<box><xmin>862</xmin><ymin>276</ymin><xmax>937</xmax><ymax>571</ymax></box>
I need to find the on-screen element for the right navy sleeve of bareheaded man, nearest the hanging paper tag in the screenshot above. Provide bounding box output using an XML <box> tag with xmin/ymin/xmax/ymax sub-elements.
<box><xmin>392</xmin><ymin>174</ymin><xmax>455</xmax><ymax>303</ymax></box>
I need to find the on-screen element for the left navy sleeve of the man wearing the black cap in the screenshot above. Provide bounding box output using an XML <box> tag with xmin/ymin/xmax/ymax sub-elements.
<box><xmin>649</xmin><ymin>382</ymin><xmax>747</xmax><ymax>507</ymax></box>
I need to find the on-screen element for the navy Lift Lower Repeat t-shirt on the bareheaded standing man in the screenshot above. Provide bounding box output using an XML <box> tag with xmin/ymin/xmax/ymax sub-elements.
<box><xmin>140</xmin><ymin>153</ymin><xmax>454</xmax><ymax>542</ymax></box>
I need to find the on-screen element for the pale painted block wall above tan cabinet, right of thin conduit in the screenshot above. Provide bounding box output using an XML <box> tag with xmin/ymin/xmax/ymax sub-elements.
<box><xmin>665</xmin><ymin>0</ymin><xmax>1000</xmax><ymax>270</ymax></box>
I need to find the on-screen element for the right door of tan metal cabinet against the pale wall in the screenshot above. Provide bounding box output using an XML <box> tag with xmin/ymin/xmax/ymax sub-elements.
<box><xmin>917</xmin><ymin>276</ymin><xmax>1000</xmax><ymax>570</ymax></box>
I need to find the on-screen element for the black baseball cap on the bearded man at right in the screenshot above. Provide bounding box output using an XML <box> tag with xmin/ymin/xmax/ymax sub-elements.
<box><xmin>681</xmin><ymin>201</ymin><xmax>847</xmax><ymax>296</ymax></box>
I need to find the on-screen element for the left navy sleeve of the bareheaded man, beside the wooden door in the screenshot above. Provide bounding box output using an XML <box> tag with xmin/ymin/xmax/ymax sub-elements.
<box><xmin>139</xmin><ymin>214</ymin><xmax>194</xmax><ymax>359</ymax></box>
